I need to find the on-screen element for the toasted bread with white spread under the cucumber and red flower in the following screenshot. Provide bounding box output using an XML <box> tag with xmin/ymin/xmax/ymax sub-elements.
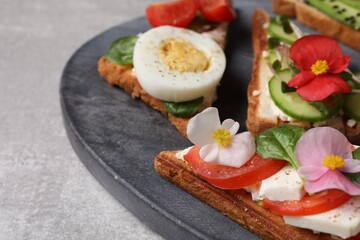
<box><xmin>246</xmin><ymin>9</ymin><xmax>360</xmax><ymax>143</ymax></box>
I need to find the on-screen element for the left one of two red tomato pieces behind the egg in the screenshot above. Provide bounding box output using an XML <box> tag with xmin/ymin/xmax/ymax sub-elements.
<box><xmin>146</xmin><ymin>0</ymin><xmax>199</xmax><ymax>27</ymax></box>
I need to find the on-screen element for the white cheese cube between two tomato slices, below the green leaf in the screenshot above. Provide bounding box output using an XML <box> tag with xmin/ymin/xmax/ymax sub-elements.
<box><xmin>259</xmin><ymin>165</ymin><xmax>305</xmax><ymax>201</ymax></box>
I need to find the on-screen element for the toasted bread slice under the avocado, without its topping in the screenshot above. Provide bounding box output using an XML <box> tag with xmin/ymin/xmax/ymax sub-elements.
<box><xmin>272</xmin><ymin>0</ymin><xmax>360</xmax><ymax>51</ymax></box>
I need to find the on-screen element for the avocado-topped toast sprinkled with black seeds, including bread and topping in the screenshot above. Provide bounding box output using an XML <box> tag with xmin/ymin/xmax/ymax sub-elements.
<box><xmin>272</xmin><ymin>0</ymin><xmax>360</xmax><ymax>51</ymax></box>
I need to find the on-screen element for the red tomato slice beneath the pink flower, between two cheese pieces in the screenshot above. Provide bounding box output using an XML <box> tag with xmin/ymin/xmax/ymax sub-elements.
<box><xmin>263</xmin><ymin>189</ymin><xmax>351</xmax><ymax>216</ymax></box>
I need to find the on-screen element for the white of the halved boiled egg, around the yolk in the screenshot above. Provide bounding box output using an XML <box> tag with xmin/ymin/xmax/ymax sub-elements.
<box><xmin>133</xmin><ymin>26</ymin><xmax>226</xmax><ymax>102</ymax></box>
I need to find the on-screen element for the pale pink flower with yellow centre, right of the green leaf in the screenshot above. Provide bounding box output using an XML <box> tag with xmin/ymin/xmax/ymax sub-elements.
<box><xmin>295</xmin><ymin>127</ymin><xmax>360</xmax><ymax>195</ymax></box>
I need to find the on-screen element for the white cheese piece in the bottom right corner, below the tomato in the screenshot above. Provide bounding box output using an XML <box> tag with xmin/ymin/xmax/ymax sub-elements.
<box><xmin>284</xmin><ymin>196</ymin><xmax>360</xmax><ymax>238</ymax></box>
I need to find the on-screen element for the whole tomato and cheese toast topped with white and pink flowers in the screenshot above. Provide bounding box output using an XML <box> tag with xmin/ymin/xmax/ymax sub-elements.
<box><xmin>154</xmin><ymin>107</ymin><xmax>360</xmax><ymax>240</ymax></box>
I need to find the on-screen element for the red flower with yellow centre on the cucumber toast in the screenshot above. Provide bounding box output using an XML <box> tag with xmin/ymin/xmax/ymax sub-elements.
<box><xmin>288</xmin><ymin>35</ymin><xmax>351</xmax><ymax>101</ymax></box>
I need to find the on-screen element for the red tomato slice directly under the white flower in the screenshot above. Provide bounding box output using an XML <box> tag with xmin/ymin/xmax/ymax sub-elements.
<box><xmin>184</xmin><ymin>146</ymin><xmax>287</xmax><ymax>189</ymax></box>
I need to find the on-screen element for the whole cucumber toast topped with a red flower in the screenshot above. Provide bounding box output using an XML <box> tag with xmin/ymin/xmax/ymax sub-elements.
<box><xmin>246</xmin><ymin>9</ymin><xmax>360</xmax><ymax>143</ymax></box>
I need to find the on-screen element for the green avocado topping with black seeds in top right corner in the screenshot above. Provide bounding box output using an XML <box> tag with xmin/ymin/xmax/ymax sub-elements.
<box><xmin>307</xmin><ymin>0</ymin><xmax>360</xmax><ymax>30</ymax></box>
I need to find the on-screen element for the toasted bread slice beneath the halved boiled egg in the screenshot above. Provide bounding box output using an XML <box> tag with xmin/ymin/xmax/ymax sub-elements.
<box><xmin>98</xmin><ymin>19</ymin><xmax>229</xmax><ymax>137</ymax></box>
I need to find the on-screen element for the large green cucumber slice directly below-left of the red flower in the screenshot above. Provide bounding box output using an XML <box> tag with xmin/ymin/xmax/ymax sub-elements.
<box><xmin>269</xmin><ymin>69</ymin><xmax>328</xmax><ymax>122</ymax></box>
